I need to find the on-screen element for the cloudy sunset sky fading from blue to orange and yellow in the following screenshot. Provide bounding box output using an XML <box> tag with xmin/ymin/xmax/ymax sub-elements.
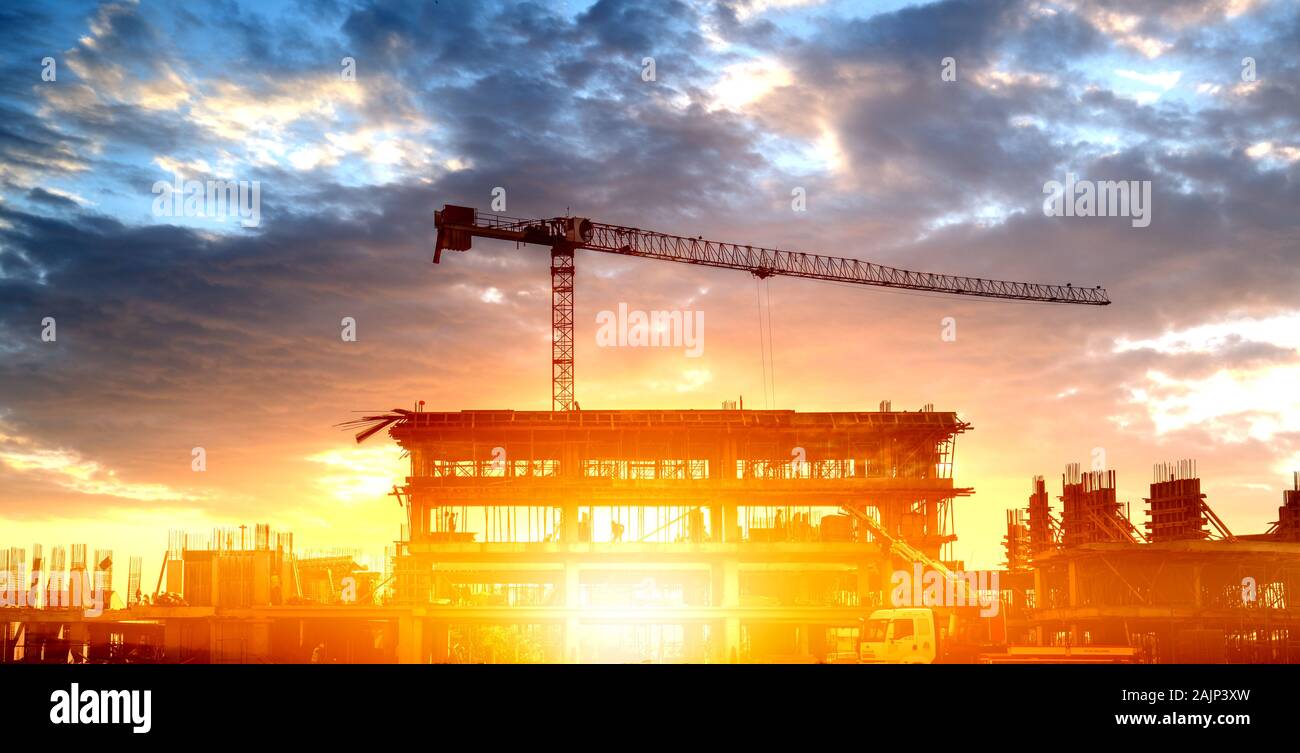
<box><xmin>0</xmin><ymin>0</ymin><xmax>1300</xmax><ymax>590</ymax></box>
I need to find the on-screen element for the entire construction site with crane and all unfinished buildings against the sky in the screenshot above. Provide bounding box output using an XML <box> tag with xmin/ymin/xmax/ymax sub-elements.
<box><xmin>0</xmin><ymin>205</ymin><xmax>1300</xmax><ymax>663</ymax></box>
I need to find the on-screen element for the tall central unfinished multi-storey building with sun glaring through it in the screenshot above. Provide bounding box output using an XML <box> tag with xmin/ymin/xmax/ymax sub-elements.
<box><xmin>358</xmin><ymin>410</ymin><xmax>971</xmax><ymax>662</ymax></box>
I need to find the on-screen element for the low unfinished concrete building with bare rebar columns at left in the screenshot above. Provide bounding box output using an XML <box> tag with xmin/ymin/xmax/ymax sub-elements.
<box><xmin>0</xmin><ymin>524</ymin><xmax>397</xmax><ymax>663</ymax></box>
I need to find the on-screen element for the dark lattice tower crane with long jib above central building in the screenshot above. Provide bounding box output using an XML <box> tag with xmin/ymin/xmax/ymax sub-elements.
<box><xmin>433</xmin><ymin>204</ymin><xmax>1110</xmax><ymax>411</ymax></box>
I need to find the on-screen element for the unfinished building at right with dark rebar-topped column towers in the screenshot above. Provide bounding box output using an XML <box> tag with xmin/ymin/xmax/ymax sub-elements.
<box><xmin>1004</xmin><ymin>460</ymin><xmax>1300</xmax><ymax>663</ymax></box>
